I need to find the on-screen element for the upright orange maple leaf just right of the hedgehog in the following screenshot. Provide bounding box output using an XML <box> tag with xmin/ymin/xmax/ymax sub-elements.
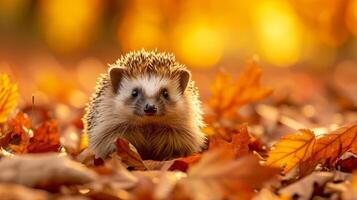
<box><xmin>209</xmin><ymin>60</ymin><xmax>272</xmax><ymax>119</ymax></box>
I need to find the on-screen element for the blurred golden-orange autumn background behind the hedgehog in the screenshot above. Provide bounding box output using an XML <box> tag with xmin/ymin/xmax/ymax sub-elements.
<box><xmin>0</xmin><ymin>0</ymin><xmax>357</xmax><ymax>135</ymax></box>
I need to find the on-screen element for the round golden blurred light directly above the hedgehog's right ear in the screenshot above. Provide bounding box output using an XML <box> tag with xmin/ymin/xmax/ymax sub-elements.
<box><xmin>174</xmin><ymin>20</ymin><xmax>224</xmax><ymax>68</ymax></box>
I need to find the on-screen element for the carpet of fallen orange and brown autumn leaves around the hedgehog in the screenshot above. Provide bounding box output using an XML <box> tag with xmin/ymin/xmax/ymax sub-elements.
<box><xmin>0</xmin><ymin>61</ymin><xmax>357</xmax><ymax>200</ymax></box>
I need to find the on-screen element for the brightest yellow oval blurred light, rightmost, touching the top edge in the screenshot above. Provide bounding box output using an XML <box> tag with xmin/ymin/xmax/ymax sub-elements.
<box><xmin>253</xmin><ymin>0</ymin><xmax>301</xmax><ymax>66</ymax></box>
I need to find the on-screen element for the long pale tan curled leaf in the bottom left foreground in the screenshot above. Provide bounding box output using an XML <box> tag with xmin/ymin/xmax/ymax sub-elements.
<box><xmin>0</xmin><ymin>153</ymin><xmax>97</xmax><ymax>188</ymax></box>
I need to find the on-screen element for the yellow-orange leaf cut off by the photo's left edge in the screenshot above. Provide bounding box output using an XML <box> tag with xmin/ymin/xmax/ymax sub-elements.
<box><xmin>0</xmin><ymin>74</ymin><xmax>18</xmax><ymax>123</ymax></box>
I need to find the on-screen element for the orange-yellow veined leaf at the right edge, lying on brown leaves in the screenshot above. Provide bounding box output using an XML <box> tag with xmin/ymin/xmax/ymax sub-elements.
<box><xmin>266</xmin><ymin>122</ymin><xmax>357</xmax><ymax>176</ymax></box>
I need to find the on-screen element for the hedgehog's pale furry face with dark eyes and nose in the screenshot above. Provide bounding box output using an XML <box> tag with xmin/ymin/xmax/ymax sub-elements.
<box><xmin>110</xmin><ymin>68</ymin><xmax>189</xmax><ymax>123</ymax></box>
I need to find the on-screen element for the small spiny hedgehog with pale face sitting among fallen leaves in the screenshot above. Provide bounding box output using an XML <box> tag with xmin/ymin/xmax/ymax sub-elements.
<box><xmin>83</xmin><ymin>50</ymin><xmax>206</xmax><ymax>160</ymax></box>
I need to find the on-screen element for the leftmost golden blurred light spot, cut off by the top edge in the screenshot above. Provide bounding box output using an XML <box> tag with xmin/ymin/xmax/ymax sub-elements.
<box><xmin>39</xmin><ymin>0</ymin><xmax>101</xmax><ymax>53</ymax></box>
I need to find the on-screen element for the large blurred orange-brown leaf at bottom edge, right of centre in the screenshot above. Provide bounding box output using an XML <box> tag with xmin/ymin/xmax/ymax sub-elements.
<box><xmin>181</xmin><ymin>149</ymin><xmax>278</xmax><ymax>199</ymax></box>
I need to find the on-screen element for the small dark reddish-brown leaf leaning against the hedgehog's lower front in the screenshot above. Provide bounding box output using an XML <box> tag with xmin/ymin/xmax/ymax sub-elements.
<box><xmin>115</xmin><ymin>137</ymin><xmax>146</xmax><ymax>170</ymax></box>
